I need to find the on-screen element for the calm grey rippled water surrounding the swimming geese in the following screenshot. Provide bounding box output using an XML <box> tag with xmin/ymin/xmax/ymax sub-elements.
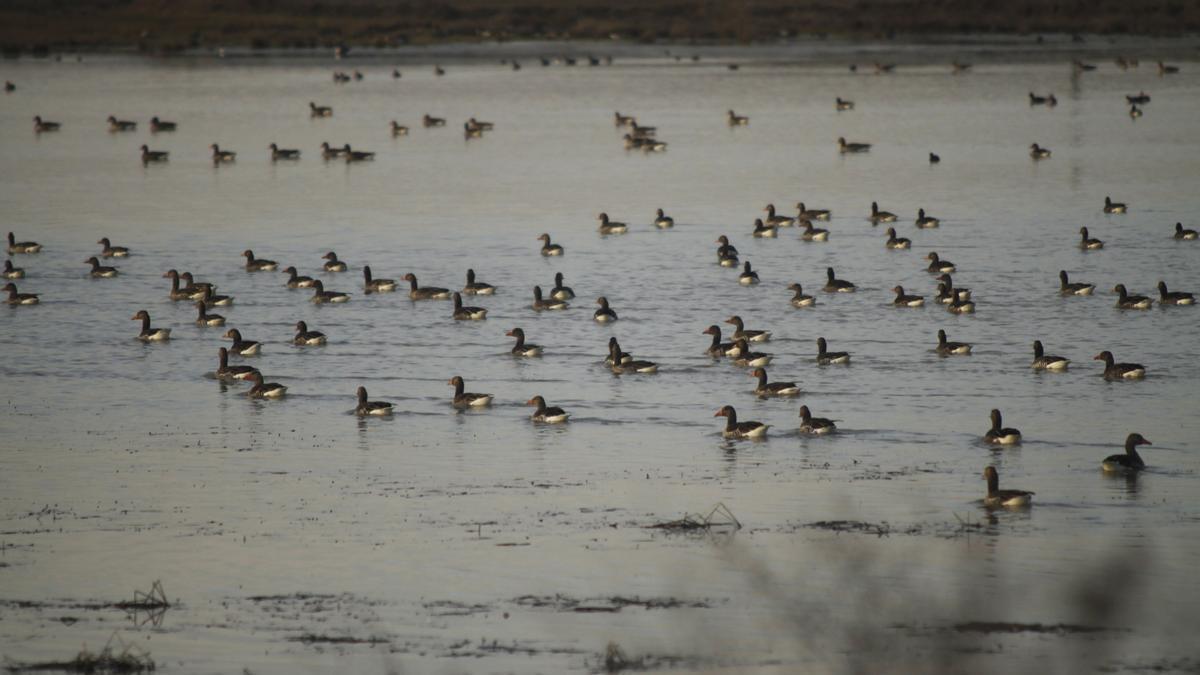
<box><xmin>0</xmin><ymin>44</ymin><xmax>1200</xmax><ymax>673</ymax></box>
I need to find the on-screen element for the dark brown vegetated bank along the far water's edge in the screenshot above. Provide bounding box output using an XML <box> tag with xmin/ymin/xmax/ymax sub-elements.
<box><xmin>0</xmin><ymin>0</ymin><xmax>1200</xmax><ymax>55</ymax></box>
